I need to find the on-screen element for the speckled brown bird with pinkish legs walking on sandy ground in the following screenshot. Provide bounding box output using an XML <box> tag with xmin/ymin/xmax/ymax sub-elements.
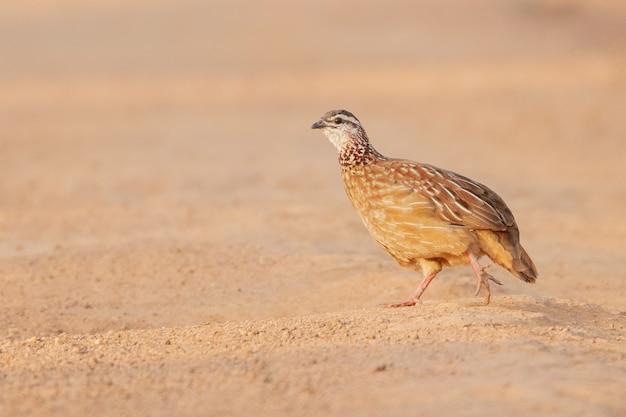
<box><xmin>311</xmin><ymin>110</ymin><xmax>538</xmax><ymax>307</ymax></box>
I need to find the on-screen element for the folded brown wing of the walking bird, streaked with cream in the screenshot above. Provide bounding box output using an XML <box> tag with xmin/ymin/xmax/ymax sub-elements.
<box><xmin>379</xmin><ymin>159</ymin><xmax>517</xmax><ymax>231</ymax></box>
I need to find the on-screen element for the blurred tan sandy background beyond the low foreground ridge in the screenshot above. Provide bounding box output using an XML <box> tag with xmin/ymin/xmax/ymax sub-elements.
<box><xmin>0</xmin><ymin>0</ymin><xmax>626</xmax><ymax>339</ymax></box>
